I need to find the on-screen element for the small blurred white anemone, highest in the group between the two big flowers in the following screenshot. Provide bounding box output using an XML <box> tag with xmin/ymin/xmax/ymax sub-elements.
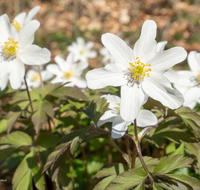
<box><xmin>67</xmin><ymin>37</ymin><xmax>97</xmax><ymax>62</ymax></box>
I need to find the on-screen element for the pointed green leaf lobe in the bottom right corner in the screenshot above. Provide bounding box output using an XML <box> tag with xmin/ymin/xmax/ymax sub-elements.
<box><xmin>162</xmin><ymin>174</ymin><xmax>200</xmax><ymax>190</ymax></box>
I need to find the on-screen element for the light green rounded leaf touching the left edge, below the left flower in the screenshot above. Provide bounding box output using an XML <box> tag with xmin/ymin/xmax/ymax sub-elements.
<box><xmin>0</xmin><ymin>131</ymin><xmax>32</xmax><ymax>146</ymax></box>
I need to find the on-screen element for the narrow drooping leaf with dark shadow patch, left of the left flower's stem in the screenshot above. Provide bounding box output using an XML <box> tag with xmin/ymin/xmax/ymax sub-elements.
<box><xmin>7</xmin><ymin>101</ymin><xmax>29</xmax><ymax>133</ymax></box>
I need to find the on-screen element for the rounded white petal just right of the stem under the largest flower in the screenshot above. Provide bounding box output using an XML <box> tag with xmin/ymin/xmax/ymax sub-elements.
<box><xmin>137</xmin><ymin>109</ymin><xmax>158</xmax><ymax>127</ymax></box>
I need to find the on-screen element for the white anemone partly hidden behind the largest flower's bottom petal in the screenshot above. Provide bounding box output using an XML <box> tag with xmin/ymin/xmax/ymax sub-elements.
<box><xmin>97</xmin><ymin>94</ymin><xmax>157</xmax><ymax>139</ymax></box>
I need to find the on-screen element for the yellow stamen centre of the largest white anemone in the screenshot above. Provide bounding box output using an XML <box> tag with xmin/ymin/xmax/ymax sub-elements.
<box><xmin>129</xmin><ymin>57</ymin><xmax>151</xmax><ymax>81</ymax></box>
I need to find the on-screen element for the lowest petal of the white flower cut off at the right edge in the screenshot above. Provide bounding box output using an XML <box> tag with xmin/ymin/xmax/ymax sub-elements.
<box><xmin>183</xmin><ymin>87</ymin><xmax>200</xmax><ymax>106</ymax></box>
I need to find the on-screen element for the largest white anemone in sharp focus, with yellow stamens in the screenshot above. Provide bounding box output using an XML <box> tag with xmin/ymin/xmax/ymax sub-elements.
<box><xmin>86</xmin><ymin>20</ymin><xmax>187</xmax><ymax>121</ymax></box>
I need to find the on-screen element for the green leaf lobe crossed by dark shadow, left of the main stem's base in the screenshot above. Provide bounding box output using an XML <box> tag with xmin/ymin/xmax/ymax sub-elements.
<box><xmin>95</xmin><ymin>163</ymin><xmax>126</xmax><ymax>178</ymax></box>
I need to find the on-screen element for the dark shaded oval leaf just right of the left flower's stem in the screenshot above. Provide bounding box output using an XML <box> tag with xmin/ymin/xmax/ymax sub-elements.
<box><xmin>36</xmin><ymin>132</ymin><xmax>60</xmax><ymax>148</ymax></box>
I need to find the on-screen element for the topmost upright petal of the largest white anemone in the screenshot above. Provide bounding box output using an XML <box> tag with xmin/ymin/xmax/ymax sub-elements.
<box><xmin>134</xmin><ymin>20</ymin><xmax>157</xmax><ymax>63</ymax></box>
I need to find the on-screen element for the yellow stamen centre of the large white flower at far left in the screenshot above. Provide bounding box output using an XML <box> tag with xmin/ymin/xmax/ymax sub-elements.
<box><xmin>2</xmin><ymin>38</ymin><xmax>19</xmax><ymax>60</ymax></box>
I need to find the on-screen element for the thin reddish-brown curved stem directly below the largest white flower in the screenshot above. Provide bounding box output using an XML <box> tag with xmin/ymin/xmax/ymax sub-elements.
<box><xmin>134</xmin><ymin>119</ymin><xmax>154</xmax><ymax>183</ymax></box>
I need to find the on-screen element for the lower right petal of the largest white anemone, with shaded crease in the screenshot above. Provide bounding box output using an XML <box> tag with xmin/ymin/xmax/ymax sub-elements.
<box><xmin>142</xmin><ymin>72</ymin><xmax>184</xmax><ymax>109</ymax></box>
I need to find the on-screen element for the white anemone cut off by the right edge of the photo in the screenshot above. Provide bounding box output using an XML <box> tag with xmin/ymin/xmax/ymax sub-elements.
<box><xmin>174</xmin><ymin>51</ymin><xmax>200</xmax><ymax>109</ymax></box>
